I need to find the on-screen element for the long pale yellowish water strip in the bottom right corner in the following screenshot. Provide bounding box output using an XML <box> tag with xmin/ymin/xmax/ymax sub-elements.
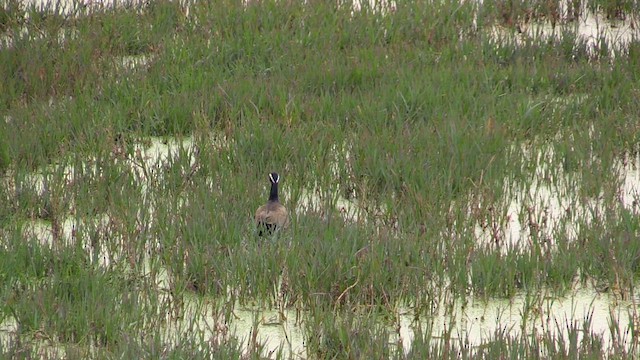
<box><xmin>399</xmin><ymin>287</ymin><xmax>637</xmax><ymax>351</ymax></box>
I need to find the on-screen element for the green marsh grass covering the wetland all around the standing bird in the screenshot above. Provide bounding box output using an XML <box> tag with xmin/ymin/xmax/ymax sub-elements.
<box><xmin>0</xmin><ymin>0</ymin><xmax>640</xmax><ymax>358</ymax></box>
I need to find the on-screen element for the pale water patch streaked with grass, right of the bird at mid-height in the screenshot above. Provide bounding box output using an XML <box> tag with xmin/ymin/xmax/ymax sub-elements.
<box><xmin>468</xmin><ymin>138</ymin><xmax>640</xmax><ymax>250</ymax></box>
